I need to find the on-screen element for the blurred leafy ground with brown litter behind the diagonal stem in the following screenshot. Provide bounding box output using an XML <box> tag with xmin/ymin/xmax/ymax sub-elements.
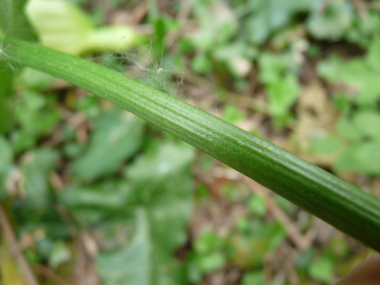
<box><xmin>0</xmin><ymin>0</ymin><xmax>380</xmax><ymax>285</ymax></box>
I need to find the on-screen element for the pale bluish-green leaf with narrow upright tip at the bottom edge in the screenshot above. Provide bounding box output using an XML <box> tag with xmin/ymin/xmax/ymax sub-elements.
<box><xmin>95</xmin><ymin>209</ymin><xmax>184</xmax><ymax>285</ymax></box>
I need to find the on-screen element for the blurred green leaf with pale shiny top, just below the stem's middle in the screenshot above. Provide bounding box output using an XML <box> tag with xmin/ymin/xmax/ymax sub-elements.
<box><xmin>126</xmin><ymin>142</ymin><xmax>194</xmax><ymax>252</ymax></box>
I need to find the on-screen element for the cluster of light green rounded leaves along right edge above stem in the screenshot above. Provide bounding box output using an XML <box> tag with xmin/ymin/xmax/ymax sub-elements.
<box><xmin>312</xmin><ymin>42</ymin><xmax>380</xmax><ymax>175</ymax></box>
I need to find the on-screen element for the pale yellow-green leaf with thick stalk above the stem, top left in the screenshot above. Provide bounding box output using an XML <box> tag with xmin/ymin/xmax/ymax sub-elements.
<box><xmin>26</xmin><ymin>0</ymin><xmax>141</xmax><ymax>55</ymax></box>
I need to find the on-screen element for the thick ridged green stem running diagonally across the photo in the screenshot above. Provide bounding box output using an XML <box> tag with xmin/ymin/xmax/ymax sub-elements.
<box><xmin>0</xmin><ymin>36</ymin><xmax>380</xmax><ymax>251</ymax></box>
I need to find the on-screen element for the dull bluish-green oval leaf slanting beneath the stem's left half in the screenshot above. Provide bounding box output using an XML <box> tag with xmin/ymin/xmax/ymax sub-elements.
<box><xmin>72</xmin><ymin>109</ymin><xmax>144</xmax><ymax>181</ymax></box>
